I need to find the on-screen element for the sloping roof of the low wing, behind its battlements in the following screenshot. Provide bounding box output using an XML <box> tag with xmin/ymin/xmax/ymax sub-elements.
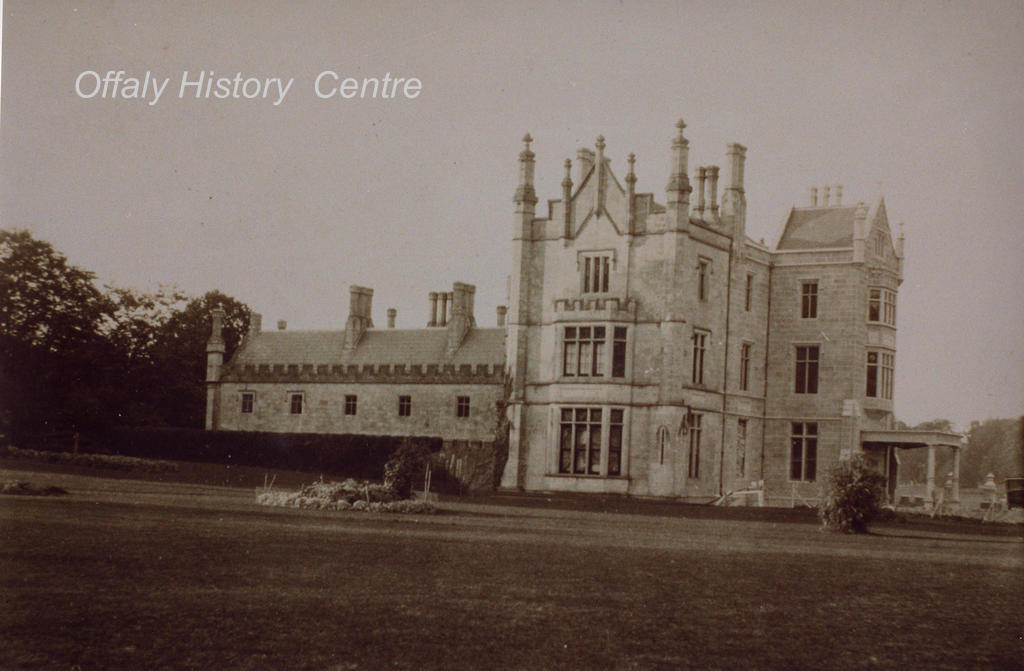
<box><xmin>231</xmin><ymin>328</ymin><xmax>505</xmax><ymax>366</ymax></box>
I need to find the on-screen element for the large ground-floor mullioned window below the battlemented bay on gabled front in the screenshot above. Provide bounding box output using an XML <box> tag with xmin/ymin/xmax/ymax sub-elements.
<box><xmin>558</xmin><ymin>408</ymin><xmax>626</xmax><ymax>475</ymax></box>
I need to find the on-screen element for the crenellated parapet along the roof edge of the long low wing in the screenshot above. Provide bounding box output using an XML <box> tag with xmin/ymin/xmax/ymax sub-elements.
<box><xmin>221</xmin><ymin>364</ymin><xmax>504</xmax><ymax>384</ymax></box>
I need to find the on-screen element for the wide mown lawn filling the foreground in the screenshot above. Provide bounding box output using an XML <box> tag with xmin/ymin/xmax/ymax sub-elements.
<box><xmin>0</xmin><ymin>466</ymin><xmax>1024</xmax><ymax>670</ymax></box>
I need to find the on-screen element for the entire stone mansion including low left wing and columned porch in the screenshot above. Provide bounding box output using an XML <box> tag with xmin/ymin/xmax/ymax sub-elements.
<box><xmin>207</xmin><ymin>121</ymin><xmax>959</xmax><ymax>505</ymax></box>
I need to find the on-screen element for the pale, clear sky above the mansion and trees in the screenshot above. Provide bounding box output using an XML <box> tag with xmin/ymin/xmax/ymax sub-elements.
<box><xmin>0</xmin><ymin>0</ymin><xmax>1024</xmax><ymax>428</ymax></box>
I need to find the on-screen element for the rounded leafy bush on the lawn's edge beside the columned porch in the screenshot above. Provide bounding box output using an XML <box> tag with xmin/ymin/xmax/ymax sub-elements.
<box><xmin>818</xmin><ymin>455</ymin><xmax>886</xmax><ymax>534</ymax></box>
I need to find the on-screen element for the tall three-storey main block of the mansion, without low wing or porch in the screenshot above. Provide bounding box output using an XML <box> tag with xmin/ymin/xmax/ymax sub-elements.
<box><xmin>503</xmin><ymin>122</ymin><xmax>902</xmax><ymax>503</ymax></box>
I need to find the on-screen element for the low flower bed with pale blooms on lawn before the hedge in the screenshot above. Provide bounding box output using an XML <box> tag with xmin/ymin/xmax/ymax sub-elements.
<box><xmin>256</xmin><ymin>478</ymin><xmax>437</xmax><ymax>513</ymax></box>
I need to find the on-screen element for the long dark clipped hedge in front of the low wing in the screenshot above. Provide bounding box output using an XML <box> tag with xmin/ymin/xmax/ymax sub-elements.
<box><xmin>17</xmin><ymin>428</ymin><xmax>442</xmax><ymax>479</ymax></box>
